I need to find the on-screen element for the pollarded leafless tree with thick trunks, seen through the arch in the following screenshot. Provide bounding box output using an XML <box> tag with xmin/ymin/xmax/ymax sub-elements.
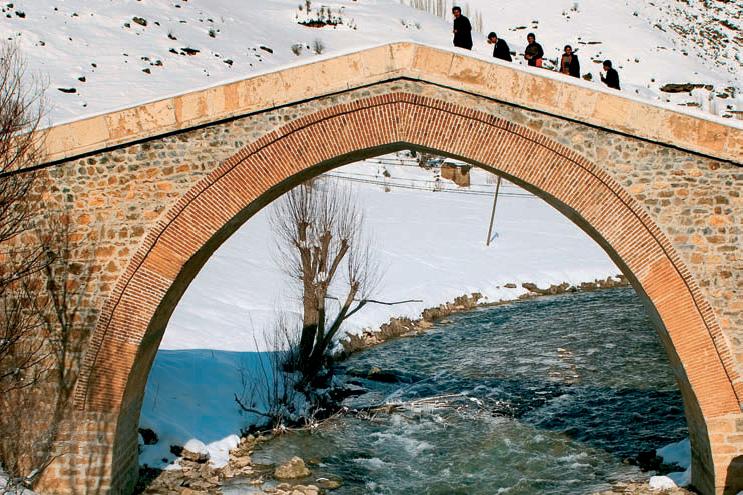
<box><xmin>271</xmin><ymin>180</ymin><xmax>384</xmax><ymax>385</ymax></box>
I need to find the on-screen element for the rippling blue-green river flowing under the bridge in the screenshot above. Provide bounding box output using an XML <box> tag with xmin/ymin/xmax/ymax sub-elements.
<box><xmin>232</xmin><ymin>289</ymin><xmax>686</xmax><ymax>494</ymax></box>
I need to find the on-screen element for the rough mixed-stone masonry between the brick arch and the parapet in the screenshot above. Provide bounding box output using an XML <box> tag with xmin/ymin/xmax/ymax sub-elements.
<box><xmin>16</xmin><ymin>81</ymin><xmax>743</xmax><ymax>494</ymax></box>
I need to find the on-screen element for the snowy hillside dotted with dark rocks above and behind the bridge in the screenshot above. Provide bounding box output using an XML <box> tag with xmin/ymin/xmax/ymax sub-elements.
<box><xmin>0</xmin><ymin>0</ymin><xmax>743</xmax><ymax>122</ymax></box>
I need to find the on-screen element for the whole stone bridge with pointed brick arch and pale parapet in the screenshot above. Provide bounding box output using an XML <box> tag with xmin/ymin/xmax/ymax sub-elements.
<box><xmin>2</xmin><ymin>43</ymin><xmax>743</xmax><ymax>495</ymax></box>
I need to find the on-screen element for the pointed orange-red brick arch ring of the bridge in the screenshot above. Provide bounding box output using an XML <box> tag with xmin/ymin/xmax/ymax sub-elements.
<box><xmin>75</xmin><ymin>93</ymin><xmax>743</xmax><ymax>493</ymax></box>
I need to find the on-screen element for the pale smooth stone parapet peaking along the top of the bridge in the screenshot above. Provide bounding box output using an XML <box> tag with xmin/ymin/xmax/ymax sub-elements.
<box><xmin>46</xmin><ymin>42</ymin><xmax>743</xmax><ymax>164</ymax></box>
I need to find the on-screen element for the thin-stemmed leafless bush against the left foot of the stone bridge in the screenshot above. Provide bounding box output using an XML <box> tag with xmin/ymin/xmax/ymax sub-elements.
<box><xmin>0</xmin><ymin>212</ymin><xmax>95</xmax><ymax>493</ymax></box>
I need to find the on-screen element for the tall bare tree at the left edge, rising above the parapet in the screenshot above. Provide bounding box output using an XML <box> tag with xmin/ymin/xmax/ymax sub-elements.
<box><xmin>0</xmin><ymin>43</ymin><xmax>44</xmax><ymax>394</ymax></box>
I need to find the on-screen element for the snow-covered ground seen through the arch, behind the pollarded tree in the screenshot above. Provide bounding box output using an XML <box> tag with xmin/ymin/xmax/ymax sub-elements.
<box><xmin>140</xmin><ymin>160</ymin><xmax>619</xmax><ymax>465</ymax></box>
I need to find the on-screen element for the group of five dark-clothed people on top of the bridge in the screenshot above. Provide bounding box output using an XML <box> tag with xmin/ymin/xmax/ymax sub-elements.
<box><xmin>452</xmin><ymin>7</ymin><xmax>620</xmax><ymax>89</ymax></box>
